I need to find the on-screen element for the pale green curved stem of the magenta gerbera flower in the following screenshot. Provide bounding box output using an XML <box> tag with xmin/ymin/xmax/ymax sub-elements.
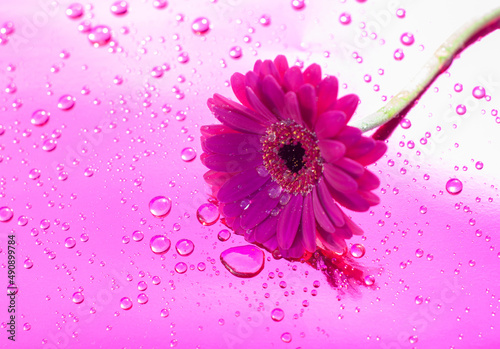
<box><xmin>350</xmin><ymin>7</ymin><xmax>500</xmax><ymax>138</ymax></box>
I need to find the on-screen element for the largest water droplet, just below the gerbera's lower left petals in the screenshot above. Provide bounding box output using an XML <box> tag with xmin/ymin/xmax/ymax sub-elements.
<box><xmin>220</xmin><ymin>245</ymin><xmax>264</xmax><ymax>278</ymax></box>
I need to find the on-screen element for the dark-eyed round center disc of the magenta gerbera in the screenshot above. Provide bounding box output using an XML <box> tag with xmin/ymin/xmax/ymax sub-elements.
<box><xmin>261</xmin><ymin>120</ymin><xmax>323</xmax><ymax>195</ymax></box>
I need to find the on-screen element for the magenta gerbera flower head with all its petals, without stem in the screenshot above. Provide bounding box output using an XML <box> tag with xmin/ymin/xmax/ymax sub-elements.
<box><xmin>201</xmin><ymin>56</ymin><xmax>387</xmax><ymax>258</ymax></box>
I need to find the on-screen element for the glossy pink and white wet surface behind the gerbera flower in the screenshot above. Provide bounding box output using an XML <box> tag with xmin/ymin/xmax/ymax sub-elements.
<box><xmin>0</xmin><ymin>0</ymin><xmax>500</xmax><ymax>349</ymax></box>
